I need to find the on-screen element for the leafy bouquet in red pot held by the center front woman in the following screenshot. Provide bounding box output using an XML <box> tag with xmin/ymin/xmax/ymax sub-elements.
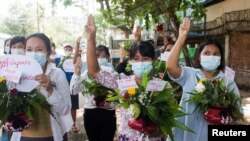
<box><xmin>107</xmin><ymin>73</ymin><xmax>192</xmax><ymax>140</ymax></box>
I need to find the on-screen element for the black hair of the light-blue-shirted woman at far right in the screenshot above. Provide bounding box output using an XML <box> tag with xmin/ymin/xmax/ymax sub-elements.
<box><xmin>194</xmin><ymin>38</ymin><xmax>225</xmax><ymax>70</ymax></box>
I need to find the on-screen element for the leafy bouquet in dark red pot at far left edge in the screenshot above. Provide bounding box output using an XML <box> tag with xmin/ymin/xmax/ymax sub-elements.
<box><xmin>0</xmin><ymin>77</ymin><xmax>51</xmax><ymax>132</ymax></box>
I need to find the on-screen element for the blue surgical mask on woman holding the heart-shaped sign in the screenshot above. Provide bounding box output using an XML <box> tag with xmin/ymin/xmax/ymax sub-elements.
<box><xmin>25</xmin><ymin>52</ymin><xmax>47</xmax><ymax>66</ymax></box>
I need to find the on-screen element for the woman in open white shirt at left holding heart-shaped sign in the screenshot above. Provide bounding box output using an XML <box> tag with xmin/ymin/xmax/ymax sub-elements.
<box><xmin>21</xmin><ymin>33</ymin><xmax>73</xmax><ymax>141</ymax></box>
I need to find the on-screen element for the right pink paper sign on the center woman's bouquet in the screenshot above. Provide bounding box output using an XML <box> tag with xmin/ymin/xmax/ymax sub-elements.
<box><xmin>146</xmin><ymin>80</ymin><xmax>167</xmax><ymax>91</ymax></box>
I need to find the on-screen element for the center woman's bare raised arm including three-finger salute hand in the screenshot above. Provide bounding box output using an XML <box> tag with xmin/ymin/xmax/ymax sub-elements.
<box><xmin>85</xmin><ymin>15</ymin><xmax>100</xmax><ymax>78</ymax></box>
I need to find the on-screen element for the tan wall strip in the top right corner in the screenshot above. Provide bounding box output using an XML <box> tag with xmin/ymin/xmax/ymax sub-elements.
<box><xmin>206</xmin><ymin>0</ymin><xmax>250</xmax><ymax>22</ymax></box>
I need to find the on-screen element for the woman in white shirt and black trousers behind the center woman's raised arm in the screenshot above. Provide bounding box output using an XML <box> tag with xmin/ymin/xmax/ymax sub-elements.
<box><xmin>70</xmin><ymin>45</ymin><xmax>116</xmax><ymax>141</ymax></box>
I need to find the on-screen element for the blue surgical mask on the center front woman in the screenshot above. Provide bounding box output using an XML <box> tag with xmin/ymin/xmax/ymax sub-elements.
<box><xmin>132</xmin><ymin>62</ymin><xmax>153</xmax><ymax>77</ymax></box>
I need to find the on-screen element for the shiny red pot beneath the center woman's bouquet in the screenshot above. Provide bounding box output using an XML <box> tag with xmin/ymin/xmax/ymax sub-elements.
<box><xmin>128</xmin><ymin>118</ymin><xmax>158</xmax><ymax>133</ymax></box>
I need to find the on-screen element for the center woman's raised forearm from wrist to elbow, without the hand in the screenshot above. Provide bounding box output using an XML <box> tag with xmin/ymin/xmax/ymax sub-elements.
<box><xmin>87</xmin><ymin>37</ymin><xmax>100</xmax><ymax>78</ymax></box>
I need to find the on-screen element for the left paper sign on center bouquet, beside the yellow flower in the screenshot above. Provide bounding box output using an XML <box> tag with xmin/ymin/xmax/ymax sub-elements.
<box><xmin>116</xmin><ymin>78</ymin><xmax>138</xmax><ymax>91</ymax></box>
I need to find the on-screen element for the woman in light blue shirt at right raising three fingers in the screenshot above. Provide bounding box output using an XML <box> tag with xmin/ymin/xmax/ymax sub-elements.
<box><xmin>167</xmin><ymin>18</ymin><xmax>240</xmax><ymax>141</ymax></box>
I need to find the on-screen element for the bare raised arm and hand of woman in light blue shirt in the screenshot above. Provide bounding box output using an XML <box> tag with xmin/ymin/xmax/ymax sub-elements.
<box><xmin>166</xmin><ymin>18</ymin><xmax>190</xmax><ymax>78</ymax></box>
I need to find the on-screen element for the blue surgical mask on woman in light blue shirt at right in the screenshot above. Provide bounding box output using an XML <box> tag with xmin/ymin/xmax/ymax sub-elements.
<box><xmin>201</xmin><ymin>56</ymin><xmax>221</xmax><ymax>71</ymax></box>
